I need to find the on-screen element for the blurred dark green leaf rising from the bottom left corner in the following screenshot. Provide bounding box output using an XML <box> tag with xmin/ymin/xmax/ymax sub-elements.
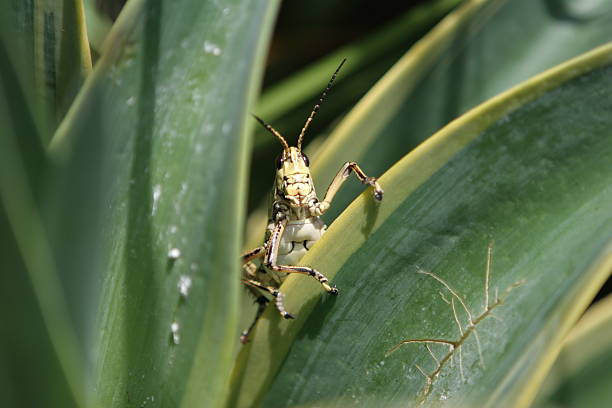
<box><xmin>0</xmin><ymin>80</ymin><xmax>84</xmax><ymax>407</ymax></box>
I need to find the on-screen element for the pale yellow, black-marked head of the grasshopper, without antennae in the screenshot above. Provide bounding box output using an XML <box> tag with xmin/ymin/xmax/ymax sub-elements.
<box><xmin>276</xmin><ymin>146</ymin><xmax>316</xmax><ymax>207</ymax></box>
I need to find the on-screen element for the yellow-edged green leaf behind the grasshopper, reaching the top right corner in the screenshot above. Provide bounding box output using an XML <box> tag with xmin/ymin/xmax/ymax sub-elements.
<box><xmin>248</xmin><ymin>0</ymin><xmax>612</xmax><ymax>249</ymax></box>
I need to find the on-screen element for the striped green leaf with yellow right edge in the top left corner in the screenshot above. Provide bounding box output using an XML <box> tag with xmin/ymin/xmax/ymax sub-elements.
<box><xmin>2</xmin><ymin>0</ymin><xmax>91</xmax><ymax>139</ymax></box>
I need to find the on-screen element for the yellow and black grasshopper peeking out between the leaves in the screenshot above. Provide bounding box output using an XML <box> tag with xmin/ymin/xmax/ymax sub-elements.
<box><xmin>240</xmin><ymin>59</ymin><xmax>383</xmax><ymax>344</ymax></box>
